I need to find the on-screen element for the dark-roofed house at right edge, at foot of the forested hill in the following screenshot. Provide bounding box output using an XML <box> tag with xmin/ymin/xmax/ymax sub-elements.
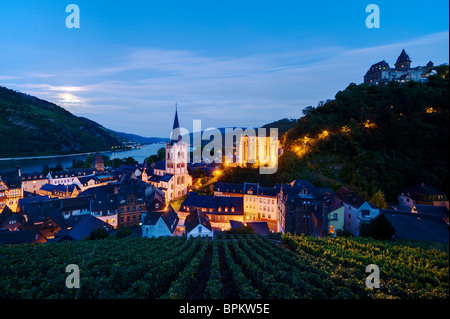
<box><xmin>398</xmin><ymin>183</ymin><xmax>449</xmax><ymax>210</ymax></box>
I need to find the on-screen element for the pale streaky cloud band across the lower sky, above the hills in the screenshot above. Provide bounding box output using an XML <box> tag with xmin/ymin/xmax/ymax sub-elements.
<box><xmin>5</xmin><ymin>31</ymin><xmax>449</xmax><ymax>136</ymax></box>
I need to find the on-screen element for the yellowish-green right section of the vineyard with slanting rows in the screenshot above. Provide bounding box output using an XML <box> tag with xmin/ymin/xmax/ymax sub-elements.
<box><xmin>283</xmin><ymin>234</ymin><xmax>449</xmax><ymax>299</ymax></box>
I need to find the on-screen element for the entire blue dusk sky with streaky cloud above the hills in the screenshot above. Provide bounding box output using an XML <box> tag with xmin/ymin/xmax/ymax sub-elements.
<box><xmin>0</xmin><ymin>0</ymin><xmax>449</xmax><ymax>137</ymax></box>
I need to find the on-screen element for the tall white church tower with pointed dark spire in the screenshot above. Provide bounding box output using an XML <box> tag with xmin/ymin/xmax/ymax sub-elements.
<box><xmin>165</xmin><ymin>105</ymin><xmax>192</xmax><ymax>201</ymax></box>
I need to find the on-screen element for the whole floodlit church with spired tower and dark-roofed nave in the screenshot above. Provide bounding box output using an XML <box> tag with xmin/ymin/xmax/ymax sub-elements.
<box><xmin>142</xmin><ymin>107</ymin><xmax>192</xmax><ymax>203</ymax></box>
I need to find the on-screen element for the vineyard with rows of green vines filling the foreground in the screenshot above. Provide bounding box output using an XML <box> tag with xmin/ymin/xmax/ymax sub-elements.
<box><xmin>0</xmin><ymin>234</ymin><xmax>449</xmax><ymax>299</ymax></box>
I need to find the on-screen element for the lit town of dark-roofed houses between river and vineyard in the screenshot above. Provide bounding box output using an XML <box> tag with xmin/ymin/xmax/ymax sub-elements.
<box><xmin>0</xmin><ymin>100</ymin><xmax>449</xmax><ymax>244</ymax></box>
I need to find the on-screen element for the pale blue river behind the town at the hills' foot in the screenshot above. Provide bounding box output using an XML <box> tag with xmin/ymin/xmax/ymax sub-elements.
<box><xmin>0</xmin><ymin>143</ymin><xmax>164</xmax><ymax>173</ymax></box>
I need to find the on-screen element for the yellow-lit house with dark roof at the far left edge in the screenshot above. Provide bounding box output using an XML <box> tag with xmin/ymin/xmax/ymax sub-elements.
<box><xmin>0</xmin><ymin>168</ymin><xmax>23</xmax><ymax>213</ymax></box>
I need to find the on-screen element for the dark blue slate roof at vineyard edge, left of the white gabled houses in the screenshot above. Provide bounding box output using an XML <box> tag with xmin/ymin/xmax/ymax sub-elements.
<box><xmin>52</xmin><ymin>215</ymin><xmax>114</xmax><ymax>242</ymax></box>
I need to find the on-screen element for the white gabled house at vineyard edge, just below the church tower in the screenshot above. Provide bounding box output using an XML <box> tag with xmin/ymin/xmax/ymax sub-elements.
<box><xmin>142</xmin><ymin>205</ymin><xmax>179</xmax><ymax>238</ymax></box>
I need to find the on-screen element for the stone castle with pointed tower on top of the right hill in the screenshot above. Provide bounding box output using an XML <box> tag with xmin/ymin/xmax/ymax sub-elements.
<box><xmin>364</xmin><ymin>49</ymin><xmax>436</xmax><ymax>85</ymax></box>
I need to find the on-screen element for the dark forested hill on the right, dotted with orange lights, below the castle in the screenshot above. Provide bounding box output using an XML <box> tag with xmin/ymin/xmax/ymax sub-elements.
<box><xmin>223</xmin><ymin>66</ymin><xmax>450</xmax><ymax>202</ymax></box>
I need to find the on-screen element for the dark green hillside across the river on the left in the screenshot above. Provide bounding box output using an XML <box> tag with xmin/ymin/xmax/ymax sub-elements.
<box><xmin>0</xmin><ymin>86</ymin><xmax>125</xmax><ymax>157</ymax></box>
